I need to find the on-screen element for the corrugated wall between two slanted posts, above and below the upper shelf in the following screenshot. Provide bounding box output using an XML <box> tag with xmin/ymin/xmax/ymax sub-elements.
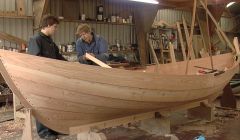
<box><xmin>50</xmin><ymin>0</ymin><xmax>136</xmax><ymax>45</ymax></box>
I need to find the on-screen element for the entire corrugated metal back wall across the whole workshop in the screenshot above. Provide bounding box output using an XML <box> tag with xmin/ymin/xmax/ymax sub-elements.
<box><xmin>0</xmin><ymin>0</ymin><xmax>234</xmax><ymax>45</ymax></box>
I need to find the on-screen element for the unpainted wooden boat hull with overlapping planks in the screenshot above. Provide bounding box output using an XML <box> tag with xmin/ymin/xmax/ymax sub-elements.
<box><xmin>0</xmin><ymin>51</ymin><xmax>238</xmax><ymax>134</ymax></box>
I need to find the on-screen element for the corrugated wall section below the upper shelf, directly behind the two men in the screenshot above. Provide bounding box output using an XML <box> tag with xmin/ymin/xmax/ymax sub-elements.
<box><xmin>53</xmin><ymin>21</ymin><xmax>136</xmax><ymax>45</ymax></box>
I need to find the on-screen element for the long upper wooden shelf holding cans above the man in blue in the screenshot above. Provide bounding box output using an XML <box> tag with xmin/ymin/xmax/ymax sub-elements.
<box><xmin>60</xmin><ymin>19</ymin><xmax>134</xmax><ymax>26</ymax></box>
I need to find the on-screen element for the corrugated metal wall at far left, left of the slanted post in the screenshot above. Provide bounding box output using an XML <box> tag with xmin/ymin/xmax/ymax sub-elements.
<box><xmin>0</xmin><ymin>0</ymin><xmax>33</xmax><ymax>48</ymax></box>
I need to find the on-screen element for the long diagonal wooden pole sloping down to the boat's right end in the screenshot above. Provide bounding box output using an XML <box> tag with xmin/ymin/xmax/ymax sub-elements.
<box><xmin>200</xmin><ymin>0</ymin><xmax>235</xmax><ymax>52</ymax></box>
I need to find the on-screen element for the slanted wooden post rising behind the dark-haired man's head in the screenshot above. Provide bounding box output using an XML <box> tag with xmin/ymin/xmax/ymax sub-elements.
<box><xmin>33</xmin><ymin>0</ymin><xmax>50</xmax><ymax>28</ymax></box>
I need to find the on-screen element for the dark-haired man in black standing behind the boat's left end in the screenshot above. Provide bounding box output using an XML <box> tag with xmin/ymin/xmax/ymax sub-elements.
<box><xmin>28</xmin><ymin>16</ymin><xmax>65</xmax><ymax>140</ymax></box>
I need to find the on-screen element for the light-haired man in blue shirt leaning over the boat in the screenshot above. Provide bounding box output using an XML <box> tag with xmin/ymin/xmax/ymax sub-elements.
<box><xmin>76</xmin><ymin>24</ymin><xmax>108</xmax><ymax>65</ymax></box>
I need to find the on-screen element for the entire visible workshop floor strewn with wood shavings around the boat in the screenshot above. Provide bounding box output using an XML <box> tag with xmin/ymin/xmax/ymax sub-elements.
<box><xmin>0</xmin><ymin>99</ymin><xmax>240</xmax><ymax>140</ymax></box>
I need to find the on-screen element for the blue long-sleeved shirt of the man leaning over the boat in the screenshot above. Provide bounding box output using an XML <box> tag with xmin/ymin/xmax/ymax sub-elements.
<box><xmin>76</xmin><ymin>33</ymin><xmax>108</xmax><ymax>63</ymax></box>
